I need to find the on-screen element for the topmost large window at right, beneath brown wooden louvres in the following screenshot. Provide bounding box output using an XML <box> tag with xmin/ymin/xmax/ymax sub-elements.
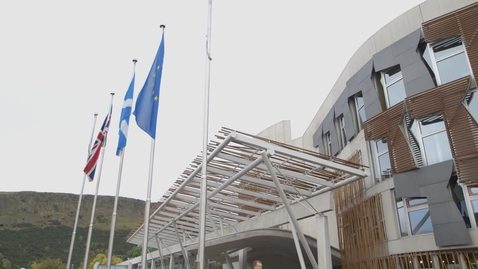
<box><xmin>430</xmin><ymin>37</ymin><xmax>471</xmax><ymax>85</ymax></box>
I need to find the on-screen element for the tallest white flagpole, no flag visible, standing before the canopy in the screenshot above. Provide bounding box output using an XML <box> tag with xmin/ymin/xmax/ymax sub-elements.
<box><xmin>197</xmin><ymin>0</ymin><xmax>212</xmax><ymax>269</ymax></box>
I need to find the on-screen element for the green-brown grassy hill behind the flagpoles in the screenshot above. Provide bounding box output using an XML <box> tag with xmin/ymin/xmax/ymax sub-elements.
<box><xmin>0</xmin><ymin>192</ymin><xmax>145</xmax><ymax>268</ymax></box>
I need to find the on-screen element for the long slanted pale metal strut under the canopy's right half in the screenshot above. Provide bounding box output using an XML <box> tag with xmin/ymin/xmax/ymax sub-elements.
<box><xmin>262</xmin><ymin>151</ymin><xmax>322</xmax><ymax>269</ymax></box>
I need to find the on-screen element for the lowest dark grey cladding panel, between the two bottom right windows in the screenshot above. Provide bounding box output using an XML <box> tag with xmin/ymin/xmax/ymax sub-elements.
<box><xmin>430</xmin><ymin>221</ymin><xmax>472</xmax><ymax>247</ymax></box>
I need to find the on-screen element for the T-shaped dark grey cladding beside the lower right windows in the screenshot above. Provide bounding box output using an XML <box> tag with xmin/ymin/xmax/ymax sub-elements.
<box><xmin>393</xmin><ymin>160</ymin><xmax>471</xmax><ymax>247</ymax></box>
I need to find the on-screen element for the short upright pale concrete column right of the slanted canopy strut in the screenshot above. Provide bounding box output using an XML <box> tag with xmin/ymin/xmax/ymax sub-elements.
<box><xmin>316</xmin><ymin>213</ymin><xmax>332</xmax><ymax>269</ymax></box>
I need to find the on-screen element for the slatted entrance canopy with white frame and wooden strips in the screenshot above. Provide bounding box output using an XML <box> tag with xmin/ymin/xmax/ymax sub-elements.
<box><xmin>127</xmin><ymin>128</ymin><xmax>366</xmax><ymax>248</ymax></box>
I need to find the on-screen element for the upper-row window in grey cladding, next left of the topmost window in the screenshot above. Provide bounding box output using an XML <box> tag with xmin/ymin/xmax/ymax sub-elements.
<box><xmin>382</xmin><ymin>65</ymin><xmax>407</xmax><ymax>107</ymax></box>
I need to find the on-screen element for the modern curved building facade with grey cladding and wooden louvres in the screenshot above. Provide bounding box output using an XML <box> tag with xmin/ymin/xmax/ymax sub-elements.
<box><xmin>124</xmin><ymin>0</ymin><xmax>478</xmax><ymax>269</ymax></box>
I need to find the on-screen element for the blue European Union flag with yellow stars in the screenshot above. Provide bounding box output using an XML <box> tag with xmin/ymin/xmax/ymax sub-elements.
<box><xmin>133</xmin><ymin>32</ymin><xmax>164</xmax><ymax>139</ymax></box>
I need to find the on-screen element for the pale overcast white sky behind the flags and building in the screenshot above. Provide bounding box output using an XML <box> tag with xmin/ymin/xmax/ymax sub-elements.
<box><xmin>0</xmin><ymin>0</ymin><xmax>423</xmax><ymax>203</ymax></box>
